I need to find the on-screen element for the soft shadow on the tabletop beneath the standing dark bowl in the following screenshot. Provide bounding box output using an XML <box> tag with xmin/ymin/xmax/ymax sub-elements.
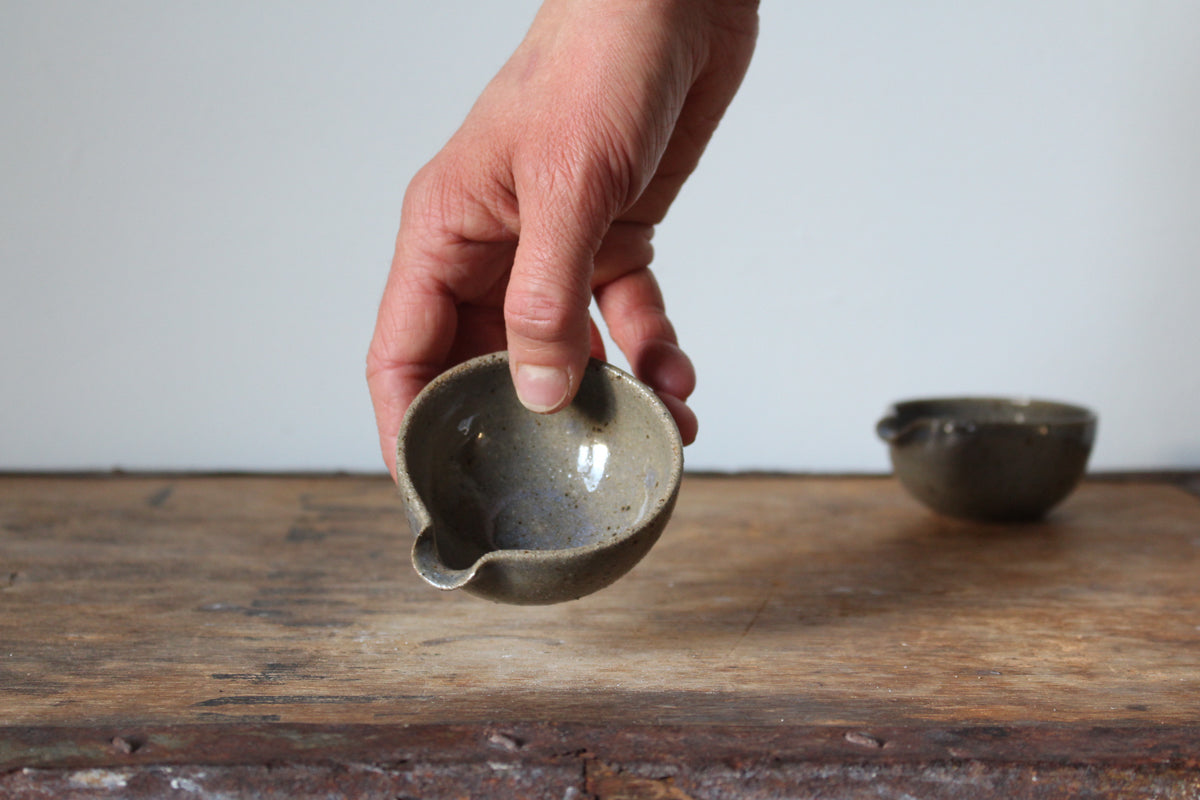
<box><xmin>614</xmin><ymin>510</ymin><xmax>1093</xmax><ymax>637</ymax></box>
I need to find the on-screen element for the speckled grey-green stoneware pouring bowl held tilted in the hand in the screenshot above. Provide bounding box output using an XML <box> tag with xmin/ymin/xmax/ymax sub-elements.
<box><xmin>396</xmin><ymin>353</ymin><xmax>683</xmax><ymax>604</ymax></box>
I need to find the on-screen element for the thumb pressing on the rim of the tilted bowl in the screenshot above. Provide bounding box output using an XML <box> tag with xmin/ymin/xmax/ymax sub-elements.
<box><xmin>504</xmin><ymin>181</ymin><xmax>611</xmax><ymax>414</ymax></box>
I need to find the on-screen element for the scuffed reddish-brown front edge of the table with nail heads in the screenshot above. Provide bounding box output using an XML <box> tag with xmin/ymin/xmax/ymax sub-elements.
<box><xmin>0</xmin><ymin>723</ymin><xmax>1200</xmax><ymax>800</ymax></box>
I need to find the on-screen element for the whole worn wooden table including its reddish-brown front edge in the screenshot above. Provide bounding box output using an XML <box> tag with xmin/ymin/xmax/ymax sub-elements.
<box><xmin>0</xmin><ymin>475</ymin><xmax>1200</xmax><ymax>800</ymax></box>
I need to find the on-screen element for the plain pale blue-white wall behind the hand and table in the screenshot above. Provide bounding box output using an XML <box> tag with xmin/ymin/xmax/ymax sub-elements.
<box><xmin>0</xmin><ymin>0</ymin><xmax>1200</xmax><ymax>470</ymax></box>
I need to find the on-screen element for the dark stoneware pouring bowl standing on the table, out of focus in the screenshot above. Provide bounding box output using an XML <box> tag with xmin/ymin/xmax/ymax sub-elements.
<box><xmin>876</xmin><ymin>397</ymin><xmax>1097</xmax><ymax>522</ymax></box>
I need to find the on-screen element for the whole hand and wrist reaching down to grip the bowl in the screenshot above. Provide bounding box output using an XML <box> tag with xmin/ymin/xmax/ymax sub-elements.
<box><xmin>367</xmin><ymin>0</ymin><xmax>758</xmax><ymax>477</ymax></box>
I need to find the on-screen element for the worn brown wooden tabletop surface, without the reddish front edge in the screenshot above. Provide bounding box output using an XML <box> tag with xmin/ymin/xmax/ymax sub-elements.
<box><xmin>0</xmin><ymin>476</ymin><xmax>1200</xmax><ymax>729</ymax></box>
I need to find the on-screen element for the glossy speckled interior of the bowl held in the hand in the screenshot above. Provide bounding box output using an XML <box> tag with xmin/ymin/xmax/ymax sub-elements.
<box><xmin>397</xmin><ymin>354</ymin><xmax>683</xmax><ymax>569</ymax></box>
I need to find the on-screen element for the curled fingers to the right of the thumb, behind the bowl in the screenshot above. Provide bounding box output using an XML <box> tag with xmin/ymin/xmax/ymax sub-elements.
<box><xmin>595</xmin><ymin>264</ymin><xmax>698</xmax><ymax>445</ymax></box>
